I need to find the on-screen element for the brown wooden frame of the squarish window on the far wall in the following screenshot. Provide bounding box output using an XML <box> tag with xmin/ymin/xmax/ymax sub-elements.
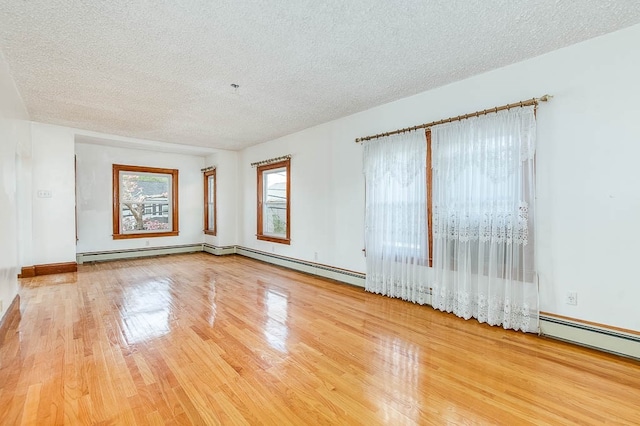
<box><xmin>112</xmin><ymin>164</ymin><xmax>179</xmax><ymax>240</ymax></box>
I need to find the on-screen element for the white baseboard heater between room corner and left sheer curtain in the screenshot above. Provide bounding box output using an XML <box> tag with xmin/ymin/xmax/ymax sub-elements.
<box><xmin>236</xmin><ymin>246</ymin><xmax>365</xmax><ymax>287</ymax></box>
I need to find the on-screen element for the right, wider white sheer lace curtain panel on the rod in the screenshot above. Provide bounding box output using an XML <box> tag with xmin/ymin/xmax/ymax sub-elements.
<box><xmin>431</xmin><ymin>107</ymin><xmax>539</xmax><ymax>332</ymax></box>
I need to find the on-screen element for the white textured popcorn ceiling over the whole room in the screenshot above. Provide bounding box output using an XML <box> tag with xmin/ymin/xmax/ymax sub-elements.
<box><xmin>0</xmin><ymin>0</ymin><xmax>640</xmax><ymax>149</ymax></box>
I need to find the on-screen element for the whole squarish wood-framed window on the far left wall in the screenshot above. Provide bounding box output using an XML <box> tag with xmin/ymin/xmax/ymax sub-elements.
<box><xmin>113</xmin><ymin>164</ymin><xmax>178</xmax><ymax>239</ymax></box>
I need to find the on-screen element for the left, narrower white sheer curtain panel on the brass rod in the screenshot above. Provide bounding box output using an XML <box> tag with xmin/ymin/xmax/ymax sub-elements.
<box><xmin>363</xmin><ymin>130</ymin><xmax>429</xmax><ymax>304</ymax></box>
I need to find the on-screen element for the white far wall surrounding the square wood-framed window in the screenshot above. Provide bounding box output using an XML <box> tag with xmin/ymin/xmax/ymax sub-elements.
<box><xmin>74</xmin><ymin>143</ymin><xmax>205</xmax><ymax>256</ymax></box>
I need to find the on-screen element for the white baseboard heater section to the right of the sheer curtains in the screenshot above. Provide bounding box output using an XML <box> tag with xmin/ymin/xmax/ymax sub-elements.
<box><xmin>540</xmin><ymin>314</ymin><xmax>640</xmax><ymax>359</ymax></box>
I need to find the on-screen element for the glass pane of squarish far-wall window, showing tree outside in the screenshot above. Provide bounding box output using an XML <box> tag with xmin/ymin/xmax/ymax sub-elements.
<box><xmin>120</xmin><ymin>171</ymin><xmax>171</xmax><ymax>233</ymax></box>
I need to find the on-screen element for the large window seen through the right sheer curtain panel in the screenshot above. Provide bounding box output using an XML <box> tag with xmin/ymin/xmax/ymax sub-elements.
<box><xmin>427</xmin><ymin>109</ymin><xmax>535</xmax><ymax>282</ymax></box>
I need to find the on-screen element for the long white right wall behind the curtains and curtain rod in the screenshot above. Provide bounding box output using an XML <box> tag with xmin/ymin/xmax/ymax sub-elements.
<box><xmin>238</xmin><ymin>25</ymin><xmax>640</xmax><ymax>331</ymax></box>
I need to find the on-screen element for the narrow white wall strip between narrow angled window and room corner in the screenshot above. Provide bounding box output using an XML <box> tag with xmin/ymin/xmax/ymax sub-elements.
<box><xmin>203</xmin><ymin>151</ymin><xmax>238</xmax><ymax>247</ymax></box>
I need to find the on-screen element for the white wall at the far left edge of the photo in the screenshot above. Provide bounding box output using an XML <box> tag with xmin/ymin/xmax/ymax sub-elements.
<box><xmin>0</xmin><ymin>52</ymin><xmax>29</xmax><ymax>320</ymax></box>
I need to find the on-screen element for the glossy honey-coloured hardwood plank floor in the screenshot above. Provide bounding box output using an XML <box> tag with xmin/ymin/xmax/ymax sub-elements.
<box><xmin>0</xmin><ymin>253</ymin><xmax>640</xmax><ymax>425</ymax></box>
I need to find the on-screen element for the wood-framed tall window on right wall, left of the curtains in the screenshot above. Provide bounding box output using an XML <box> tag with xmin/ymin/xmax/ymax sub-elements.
<box><xmin>257</xmin><ymin>160</ymin><xmax>291</xmax><ymax>244</ymax></box>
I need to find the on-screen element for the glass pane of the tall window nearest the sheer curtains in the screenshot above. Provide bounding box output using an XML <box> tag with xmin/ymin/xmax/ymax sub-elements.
<box><xmin>262</xmin><ymin>167</ymin><xmax>287</xmax><ymax>238</ymax></box>
